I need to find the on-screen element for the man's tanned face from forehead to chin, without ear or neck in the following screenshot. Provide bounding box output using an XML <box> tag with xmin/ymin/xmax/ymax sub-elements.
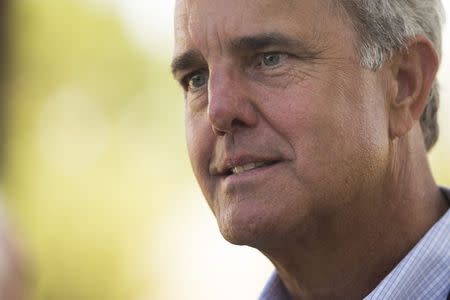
<box><xmin>173</xmin><ymin>0</ymin><xmax>389</xmax><ymax>247</ymax></box>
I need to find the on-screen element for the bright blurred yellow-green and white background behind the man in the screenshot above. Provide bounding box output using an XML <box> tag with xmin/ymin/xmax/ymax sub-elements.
<box><xmin>4</xmin><ymin>0</ymin><xmax>450</xmax><ymax>300</ymax></box>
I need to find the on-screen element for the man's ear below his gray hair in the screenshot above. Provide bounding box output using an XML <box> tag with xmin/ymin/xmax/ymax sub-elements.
<box><xmin>389</xmin><ymin>36</ymin><xmax>439</xmax><ymax>139</ymax></box>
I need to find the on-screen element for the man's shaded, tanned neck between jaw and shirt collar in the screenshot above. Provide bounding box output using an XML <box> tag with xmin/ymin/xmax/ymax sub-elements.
<box><xmin>260</xmin><ymin>127</ymin><xmax>448</xmax><ymax>299</ymax></box>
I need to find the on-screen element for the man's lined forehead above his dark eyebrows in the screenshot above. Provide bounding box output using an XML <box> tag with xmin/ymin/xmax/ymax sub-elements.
<box><xmin>175</xmin><ymin>0</ymin><xmax>342</xmax><ymax>55</ymax></box>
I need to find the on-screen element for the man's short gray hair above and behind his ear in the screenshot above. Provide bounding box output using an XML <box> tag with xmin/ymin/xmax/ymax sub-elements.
<box><xmin>332</xmin><ymin>0</ymin><xmax>444</xmax><ymax>150</ymax></box>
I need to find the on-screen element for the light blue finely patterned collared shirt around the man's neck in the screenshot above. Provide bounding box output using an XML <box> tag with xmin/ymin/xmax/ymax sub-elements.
<box><xmin>259</xmin><ymin>190</ymin><xmax>450</xmax><ymax>300</ymax></box>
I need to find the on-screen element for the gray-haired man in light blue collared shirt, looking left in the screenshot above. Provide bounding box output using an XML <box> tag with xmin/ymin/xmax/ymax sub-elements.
<box><xmin>172</xmin><ymin>0</ymin><xmax>450</xmax><ymax>299</ymax></box>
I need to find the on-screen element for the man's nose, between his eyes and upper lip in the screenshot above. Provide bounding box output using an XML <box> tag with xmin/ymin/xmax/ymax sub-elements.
<box><xmin>208</xmin><ymin>69</ymin><xmax>258</xmax><ymax>136</ymax></box>
